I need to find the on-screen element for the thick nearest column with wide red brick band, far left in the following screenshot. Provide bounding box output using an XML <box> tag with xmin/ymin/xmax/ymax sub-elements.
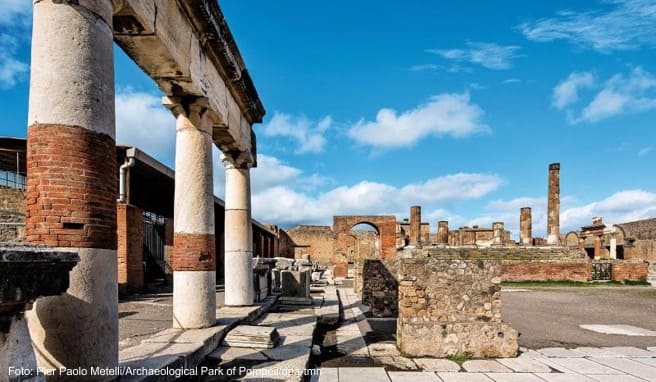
<box><xmin>26</xmin><ymin>0</ymin><xmax>118</xmax><ymax>370</ymax></box>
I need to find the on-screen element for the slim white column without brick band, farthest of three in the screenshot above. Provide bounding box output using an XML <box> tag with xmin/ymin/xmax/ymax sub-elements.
<box><xmin>221</xmin><ymin>152</ymin><xmax>253</xmax><ymax>306</ymax></box>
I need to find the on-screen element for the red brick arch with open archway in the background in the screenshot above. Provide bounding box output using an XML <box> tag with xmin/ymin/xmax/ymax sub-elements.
<box><xmin>333</xmin><ymin>215</ymin><xmax>396</xmax><ymax>277</ymax></box>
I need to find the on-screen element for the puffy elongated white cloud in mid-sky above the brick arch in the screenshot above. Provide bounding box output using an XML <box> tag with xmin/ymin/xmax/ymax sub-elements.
<box><xmin>348</xmin><ymin>93</ymin><xmax>489</xmax><ymax>148</ymax></box>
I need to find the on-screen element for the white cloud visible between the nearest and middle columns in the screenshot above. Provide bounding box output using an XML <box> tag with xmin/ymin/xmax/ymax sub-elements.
<box><xmin>116</xmin><ymin>89</ymin><xmax>175</xmax><ymax>167</ymax></box>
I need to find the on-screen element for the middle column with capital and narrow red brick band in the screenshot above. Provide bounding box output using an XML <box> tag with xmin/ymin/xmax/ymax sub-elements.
<box><xmin>164</xmin><ymin>98</ymin><xmax>216</xmax><ymax>329</ymax></box>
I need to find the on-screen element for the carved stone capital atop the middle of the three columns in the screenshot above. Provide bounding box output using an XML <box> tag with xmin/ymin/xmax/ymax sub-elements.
<box><xmin>162</xmin><ymin>96</ymin><xmax>222</xmax><ymax>135</ymax></box>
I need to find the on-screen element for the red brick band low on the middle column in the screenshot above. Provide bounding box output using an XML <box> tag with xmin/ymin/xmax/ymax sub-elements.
<box><xmin>173</xmin><ymin>233</ymin><xmax>217</xmax><ymax>272</ymax></box>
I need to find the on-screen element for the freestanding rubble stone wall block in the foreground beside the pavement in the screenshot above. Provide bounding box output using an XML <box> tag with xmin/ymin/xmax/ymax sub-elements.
<box><xmin>397</xmin><ymin>249</ymin><xmax>518</xmax><ymax>358</ymax></box>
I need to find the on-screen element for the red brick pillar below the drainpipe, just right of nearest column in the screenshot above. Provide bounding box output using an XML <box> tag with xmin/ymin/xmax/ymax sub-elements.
<box><xmin>116</xmin><ymin>203</ymin><xmax>144</xmax><ymax>293</ymax></box>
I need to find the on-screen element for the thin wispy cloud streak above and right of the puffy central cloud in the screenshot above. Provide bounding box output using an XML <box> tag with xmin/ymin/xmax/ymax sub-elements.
<box><xmin>427</xmin><ymin>41</ymin><xmax>520</xmax><ymax>70</ymax></box>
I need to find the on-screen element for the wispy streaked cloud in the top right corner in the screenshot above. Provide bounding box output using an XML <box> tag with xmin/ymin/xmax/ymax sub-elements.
<box><xmin>518</xmin><ymin>0</ymin><xmax>656</xmax><ymax>53</ymax></box>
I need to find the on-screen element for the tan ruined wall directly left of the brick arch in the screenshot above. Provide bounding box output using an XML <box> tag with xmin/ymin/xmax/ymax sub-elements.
<box><xmin>287</xmin><ymin>225</ymin><xmax>335</xmax><ymax>265</ymax></box>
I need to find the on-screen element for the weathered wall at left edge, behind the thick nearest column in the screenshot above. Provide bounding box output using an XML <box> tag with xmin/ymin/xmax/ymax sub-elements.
<box><xmin>0</xmin><ymin>186</ymin><xmax>26</xmax><ymax>242</ymax></box>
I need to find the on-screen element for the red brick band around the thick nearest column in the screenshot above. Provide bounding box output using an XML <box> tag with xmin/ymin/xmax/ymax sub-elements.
<box><xmin>26</xmin><ymin>124</ymin><xmax>117</xmax><ymax>249</ymax></box>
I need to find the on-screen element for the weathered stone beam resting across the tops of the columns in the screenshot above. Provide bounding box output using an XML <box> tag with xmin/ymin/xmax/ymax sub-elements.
<box><xmin>113</xmin><ymin>0</ymin><xmax>265</xmax><ymax>156</ymax></box>
